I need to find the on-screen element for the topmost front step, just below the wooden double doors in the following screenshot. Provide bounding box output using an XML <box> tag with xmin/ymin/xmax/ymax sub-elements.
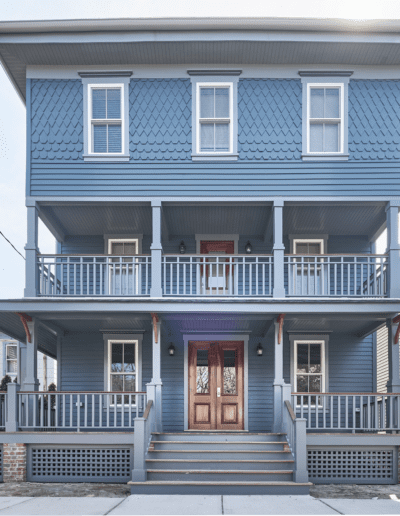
<box><xmin>152</xmin><ymin>431</ymin><xmax>286</xmax><ymax>442</ymax></box>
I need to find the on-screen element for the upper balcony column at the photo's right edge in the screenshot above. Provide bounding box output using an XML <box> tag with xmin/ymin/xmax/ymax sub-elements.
<box><xmin>386</xmin><ymin>202</ymin><xmax>400</xmax><ymax>297</ymax></box>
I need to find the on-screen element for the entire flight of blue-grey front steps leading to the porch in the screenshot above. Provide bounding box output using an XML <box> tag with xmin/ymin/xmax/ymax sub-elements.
<box><xmin>128</xmin><ymin>431</ymin><xmax>311</xmax><ymax>495</ymax></box>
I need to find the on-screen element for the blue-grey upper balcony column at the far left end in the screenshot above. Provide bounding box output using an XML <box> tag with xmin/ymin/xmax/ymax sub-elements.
<box><xmin>24</xmin><ymin>206</ymin><xmax>39</xmax><ymax>297</ymax></box>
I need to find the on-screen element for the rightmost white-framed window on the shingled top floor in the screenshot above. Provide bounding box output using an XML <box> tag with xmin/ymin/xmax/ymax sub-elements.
<box><xmin>307</xmin><ymin>84</ymin><xmax>344</xmax><ymax>154</ymax></box>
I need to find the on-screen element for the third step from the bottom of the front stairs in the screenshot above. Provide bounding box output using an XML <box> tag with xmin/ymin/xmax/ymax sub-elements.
<box><xmin>146</xmin><ymin>456</ymin><xmax>294</xmax><ymax>471</ymax></box>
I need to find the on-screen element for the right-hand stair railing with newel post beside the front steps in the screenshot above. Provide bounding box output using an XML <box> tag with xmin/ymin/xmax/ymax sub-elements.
<box><xmin>283</xmin><ymin>400</ymin><xmax>308</xmax><ymax>483</ymax></box>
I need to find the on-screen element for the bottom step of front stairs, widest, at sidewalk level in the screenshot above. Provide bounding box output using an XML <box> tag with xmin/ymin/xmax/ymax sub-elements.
<box><xmin>128</xmin><ymin>480</ymin><xmax>312</xmax><ymax>495</ymax></box>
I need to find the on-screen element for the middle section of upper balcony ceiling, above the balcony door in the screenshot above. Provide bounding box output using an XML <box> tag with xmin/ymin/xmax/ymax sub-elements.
<box><xmin>163</xmin><ymin>204</ymin><xmax>272</xmax><ymax>238</ymax></box>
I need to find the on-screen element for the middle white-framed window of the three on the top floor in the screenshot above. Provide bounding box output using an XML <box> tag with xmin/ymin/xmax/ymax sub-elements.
<box><xmin>197</xmin><ymin>83</ymin><xmax>233</xmax><ymax>154</ymax></box>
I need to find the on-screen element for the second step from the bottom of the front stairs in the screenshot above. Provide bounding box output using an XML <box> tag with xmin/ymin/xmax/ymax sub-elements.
<box><xmin>147</xmin><ymin>470</ymin><xmax>293</xmax><ymax>482</ymax></box>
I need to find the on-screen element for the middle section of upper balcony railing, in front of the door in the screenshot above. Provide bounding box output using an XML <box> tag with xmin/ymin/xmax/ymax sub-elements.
<box><xmin>162</xmin><ymin>254</ymin><xmax>273</xmax><ymax>297</ymax></box>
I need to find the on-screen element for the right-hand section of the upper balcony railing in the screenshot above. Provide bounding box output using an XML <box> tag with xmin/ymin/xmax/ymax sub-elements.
<box><xmin>285</xmin><ymin>254</ymin><xmax>389</xmax><ymax>297</ymax></box>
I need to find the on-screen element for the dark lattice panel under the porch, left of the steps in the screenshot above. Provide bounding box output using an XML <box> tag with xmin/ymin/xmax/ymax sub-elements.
<box><xmin>27</xmin><ymin>445</ymin><xmax>133</xmax><ymax>483</ymax></box>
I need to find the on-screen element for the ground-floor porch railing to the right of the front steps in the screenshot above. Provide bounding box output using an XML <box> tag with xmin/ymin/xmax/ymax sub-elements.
<box><xmin>292</xmin><ymin>393</ymin><xmax>400</xmax><ymax>432</ymax></box>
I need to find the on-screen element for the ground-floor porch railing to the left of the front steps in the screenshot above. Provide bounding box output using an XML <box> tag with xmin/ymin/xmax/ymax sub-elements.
<box><xmin>18</xmin><ymin>391</ymin><xmax>147</xmax><ymax>431</ymax></box>
